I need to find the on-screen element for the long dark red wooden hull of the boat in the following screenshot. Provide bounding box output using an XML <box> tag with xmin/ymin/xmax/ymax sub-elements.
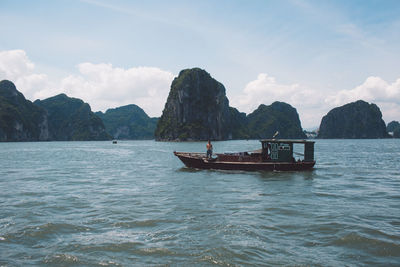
<box><xmin>174</xmin><ymin>152</ymin><xmax>315</xmax><ymax>171</ymax></box>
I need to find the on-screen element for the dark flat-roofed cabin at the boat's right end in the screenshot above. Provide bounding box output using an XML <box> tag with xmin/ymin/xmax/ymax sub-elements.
<box><xmin>260</xmin><ymin>139</ymin><xmax>315</xmax><ymax>162</ymax></box>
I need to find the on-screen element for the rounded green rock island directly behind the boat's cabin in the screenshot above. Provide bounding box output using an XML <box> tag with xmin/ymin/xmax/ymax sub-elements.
<box><xmin>247</xmin><ymin>102</ymin><xmax>307</xmax><ymax>139</ymax></box>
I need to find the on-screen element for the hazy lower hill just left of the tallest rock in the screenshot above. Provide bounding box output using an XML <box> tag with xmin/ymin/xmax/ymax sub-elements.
<box><xmin>96</xmin><ymin>105</ymin><xmax>158</xmax><ymax>139</ymax></box>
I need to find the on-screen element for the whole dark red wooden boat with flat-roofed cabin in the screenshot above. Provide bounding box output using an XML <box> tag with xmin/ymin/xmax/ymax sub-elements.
<box><xmin>174</xmin><ymin>139</ymin><xmax>315</xmax><ymax>171</ymax></box>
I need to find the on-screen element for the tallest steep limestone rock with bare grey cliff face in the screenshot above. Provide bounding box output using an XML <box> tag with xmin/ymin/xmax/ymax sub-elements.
<box><xmin>155</xmin><ymin>68</ymin><xmax>232</xmax><ymax>141</ymax></box>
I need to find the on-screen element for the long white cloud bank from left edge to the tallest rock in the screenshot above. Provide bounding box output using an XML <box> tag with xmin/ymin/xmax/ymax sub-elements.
<box><xmin>0</xmin><ymin>50</ymin><xmax>174</xmax><ymax>116</ymax></box>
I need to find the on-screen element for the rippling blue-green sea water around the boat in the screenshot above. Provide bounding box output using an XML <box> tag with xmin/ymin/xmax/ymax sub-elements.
<box><xmin>0</xmin><ymin>139</ymin><xmax>400</xmax><ymax>266</ymax></box>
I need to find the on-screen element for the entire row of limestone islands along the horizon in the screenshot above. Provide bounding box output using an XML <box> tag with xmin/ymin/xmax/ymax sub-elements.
<box><xmin>0</xmin><ymin>68</ymin><xmax>400</xmax><ymax>142</ymax></box>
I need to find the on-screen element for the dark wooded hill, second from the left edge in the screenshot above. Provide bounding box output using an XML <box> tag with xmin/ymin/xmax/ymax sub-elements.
<box><xmin>34</xmin><ymin>94</ymin><xmax>111</xmax><ymax>141</ymax></box>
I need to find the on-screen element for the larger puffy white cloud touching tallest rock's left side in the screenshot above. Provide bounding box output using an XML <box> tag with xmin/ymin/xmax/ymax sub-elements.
<box><xmin>60</xmin><ymin>63</ymin><xmax>174</xmax><ymax>116</ymax></box>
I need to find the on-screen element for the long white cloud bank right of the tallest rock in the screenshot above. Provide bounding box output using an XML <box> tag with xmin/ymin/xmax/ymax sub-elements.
<box><xmin>231</xmin><ymin>73</ymin><xmax>400</xmax><ymax>127</ymax></box>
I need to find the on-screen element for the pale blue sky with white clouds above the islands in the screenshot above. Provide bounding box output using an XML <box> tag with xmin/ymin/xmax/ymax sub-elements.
<box><xmin>0</xmin><ymin>0</ymin><xmax>400</xmax><ymax>129</ymax></box>
